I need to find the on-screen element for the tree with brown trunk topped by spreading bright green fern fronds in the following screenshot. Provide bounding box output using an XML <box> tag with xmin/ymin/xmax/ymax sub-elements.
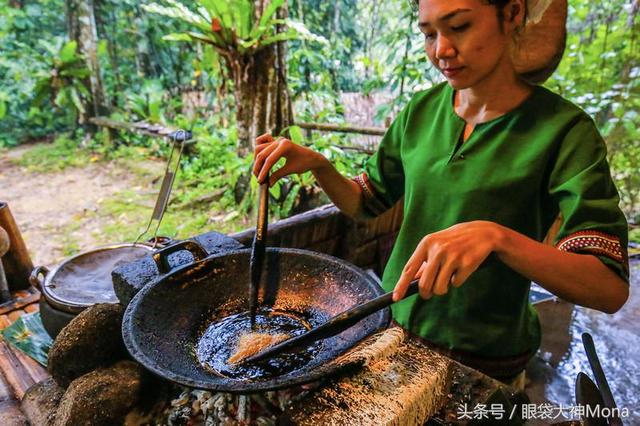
<box><xmin>144</xmin><ymin>0</ymin><xmax>320</xmax><ymax>157</ymax></box>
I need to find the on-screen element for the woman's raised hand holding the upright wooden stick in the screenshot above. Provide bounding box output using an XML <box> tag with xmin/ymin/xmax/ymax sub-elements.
<box><xmin>253</xmin><ymin>133</ymin><xmax>330</xmax><ymax>186</ymax></box>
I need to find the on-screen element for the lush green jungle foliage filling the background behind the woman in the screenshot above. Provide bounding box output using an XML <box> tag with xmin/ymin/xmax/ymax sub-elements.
<box><xmin>0</xmin><ymin>0</ymin><xmax>640</xmax><ymax>230</ymax></box>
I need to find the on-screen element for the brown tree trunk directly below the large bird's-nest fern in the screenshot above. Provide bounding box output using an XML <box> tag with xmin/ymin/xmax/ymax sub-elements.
<box><xmin>227</xmin><ymin>0</ymin><xmax>293</xmax><ymax>157</ymax></box>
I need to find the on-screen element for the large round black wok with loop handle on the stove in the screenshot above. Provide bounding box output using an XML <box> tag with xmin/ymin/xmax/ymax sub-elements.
<box><xmin>122</xmin><ymin>240</ymin><xmax>389</xmax><ymax>393</ymax></box>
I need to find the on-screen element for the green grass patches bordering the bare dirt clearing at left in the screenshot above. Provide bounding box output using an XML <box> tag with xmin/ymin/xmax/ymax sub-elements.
<box><xmin>14</xmin><ymin>137</ymin><xmax>254</xmax><ymax>256</ymax></box>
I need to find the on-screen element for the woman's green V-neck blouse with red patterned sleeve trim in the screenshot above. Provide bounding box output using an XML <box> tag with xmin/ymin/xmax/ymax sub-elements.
<box><xmin>354</xmin><ymin>83</ymin><xmax>628</xmax><ymax>357</ymax></box>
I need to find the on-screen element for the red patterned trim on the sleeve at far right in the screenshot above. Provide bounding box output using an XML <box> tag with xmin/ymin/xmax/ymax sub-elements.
<box><xmin>556</xmin><ymin>230</ymin><xmax>627</xmax><ymax>264</ymax></box>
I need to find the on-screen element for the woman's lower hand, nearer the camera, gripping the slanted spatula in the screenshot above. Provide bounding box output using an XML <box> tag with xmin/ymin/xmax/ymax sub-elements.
<box><xmin>393</xmin><ymin>221</ymin><xmax>500</xmax><ymax>301</ymax></box>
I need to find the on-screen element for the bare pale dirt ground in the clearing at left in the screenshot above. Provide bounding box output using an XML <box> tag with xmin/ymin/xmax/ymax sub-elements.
<box><xmin>0</xmin><ymin>146</ymin><xmax>162</xmax><ymax>266</ymax></box>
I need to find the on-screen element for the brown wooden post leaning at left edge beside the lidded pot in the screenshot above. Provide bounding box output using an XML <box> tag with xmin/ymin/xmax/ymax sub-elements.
<box><xmin>0</xmin><ymin>201</ymin><xmax>33</xmax><ymax>291</ymax></box>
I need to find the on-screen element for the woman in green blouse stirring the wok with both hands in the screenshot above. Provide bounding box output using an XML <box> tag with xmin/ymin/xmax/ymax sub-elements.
<box><xmin>254</xmin><ymin>0</ymin><xmax>628</xmax><ymax>380</ymax></box>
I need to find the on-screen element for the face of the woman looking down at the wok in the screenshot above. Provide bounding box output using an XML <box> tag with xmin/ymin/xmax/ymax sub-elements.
<box><xmin>419</xmin><ymin>0</ymin><xmax>523</xmax><ymax>90</ymax></box>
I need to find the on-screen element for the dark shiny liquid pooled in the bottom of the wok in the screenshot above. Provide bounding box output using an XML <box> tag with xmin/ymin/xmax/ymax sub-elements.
<box><xmin>196</xmin><ymin>309</ymin><xmax>321</xmax><ymax>379</ymax></box>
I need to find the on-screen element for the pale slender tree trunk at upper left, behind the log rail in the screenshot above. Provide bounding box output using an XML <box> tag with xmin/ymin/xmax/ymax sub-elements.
<box><xmin>65</xmin><ymin>0</ymin><xmax>107</xmax><ymax>123</ymax></box>
